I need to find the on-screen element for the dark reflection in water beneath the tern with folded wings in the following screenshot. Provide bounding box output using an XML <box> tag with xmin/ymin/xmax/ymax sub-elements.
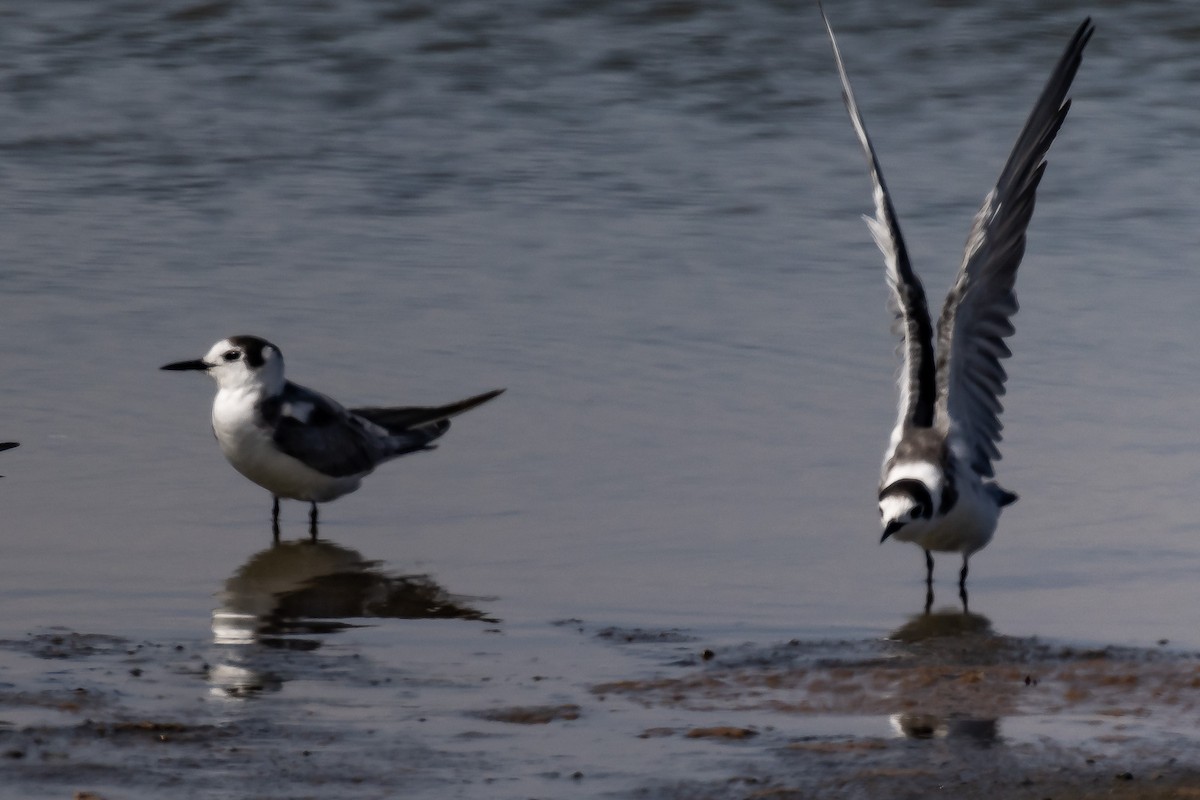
<box><xmin>212</xmin><ymin>541</ymin><xmax>494</xmax><ymax>648</ymax></box>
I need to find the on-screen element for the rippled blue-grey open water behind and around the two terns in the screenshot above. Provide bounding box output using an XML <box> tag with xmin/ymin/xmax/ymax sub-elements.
<box><xmin>0</xmin><ymin>0</ymin><xmax>1200</xmax><ymax>796</ymax></box>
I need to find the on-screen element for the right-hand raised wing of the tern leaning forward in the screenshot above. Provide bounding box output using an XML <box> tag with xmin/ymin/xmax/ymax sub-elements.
<box><xmin>937</xmin><ymin>19</ymin><xmax>1096</xmax><ymax>477</ymax></box>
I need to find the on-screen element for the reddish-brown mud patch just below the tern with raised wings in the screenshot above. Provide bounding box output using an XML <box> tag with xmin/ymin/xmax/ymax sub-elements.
<box><xmin>592</xmin><ymin>633</ymin><xmax>1200</xmax><ymax>723</ymax></box>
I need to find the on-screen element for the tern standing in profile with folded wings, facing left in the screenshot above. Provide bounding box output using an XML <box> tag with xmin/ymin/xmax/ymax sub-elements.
<box><xmin>162</xmin><ymin>336</ymin><xmax>504</xmax><ymax>541</ymax></box>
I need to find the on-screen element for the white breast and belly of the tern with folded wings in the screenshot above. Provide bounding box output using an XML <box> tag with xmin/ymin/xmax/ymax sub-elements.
<box><xmin>212</xmin><ymin>393</ymin><xmax>362</xmax><ymax>503</ymax></box>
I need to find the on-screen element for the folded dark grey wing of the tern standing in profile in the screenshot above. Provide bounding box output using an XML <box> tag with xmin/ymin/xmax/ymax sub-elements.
<box><xmin>260</xmin><ymin>381</ymin><xmax>449</xmax><ymax>477</ymax></box>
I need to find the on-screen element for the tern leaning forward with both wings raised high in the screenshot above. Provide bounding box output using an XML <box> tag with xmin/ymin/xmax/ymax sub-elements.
<box><xmin>822</xmin><ymin>6</ymin><xmax>1094</xmax><ymax>602</ymax></box>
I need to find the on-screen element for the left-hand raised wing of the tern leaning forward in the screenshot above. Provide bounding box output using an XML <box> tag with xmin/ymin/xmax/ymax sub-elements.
<box><xmin>821</xmin><ymin>8</ymin><xmax>936</xmax><ymax>443</ymax></box>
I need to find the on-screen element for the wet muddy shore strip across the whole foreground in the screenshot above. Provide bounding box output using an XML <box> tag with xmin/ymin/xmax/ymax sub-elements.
<box><xmin>0</xmin><ymin>610</ymin><xmax>1200</xmax><ymax>800</ymax></box>
